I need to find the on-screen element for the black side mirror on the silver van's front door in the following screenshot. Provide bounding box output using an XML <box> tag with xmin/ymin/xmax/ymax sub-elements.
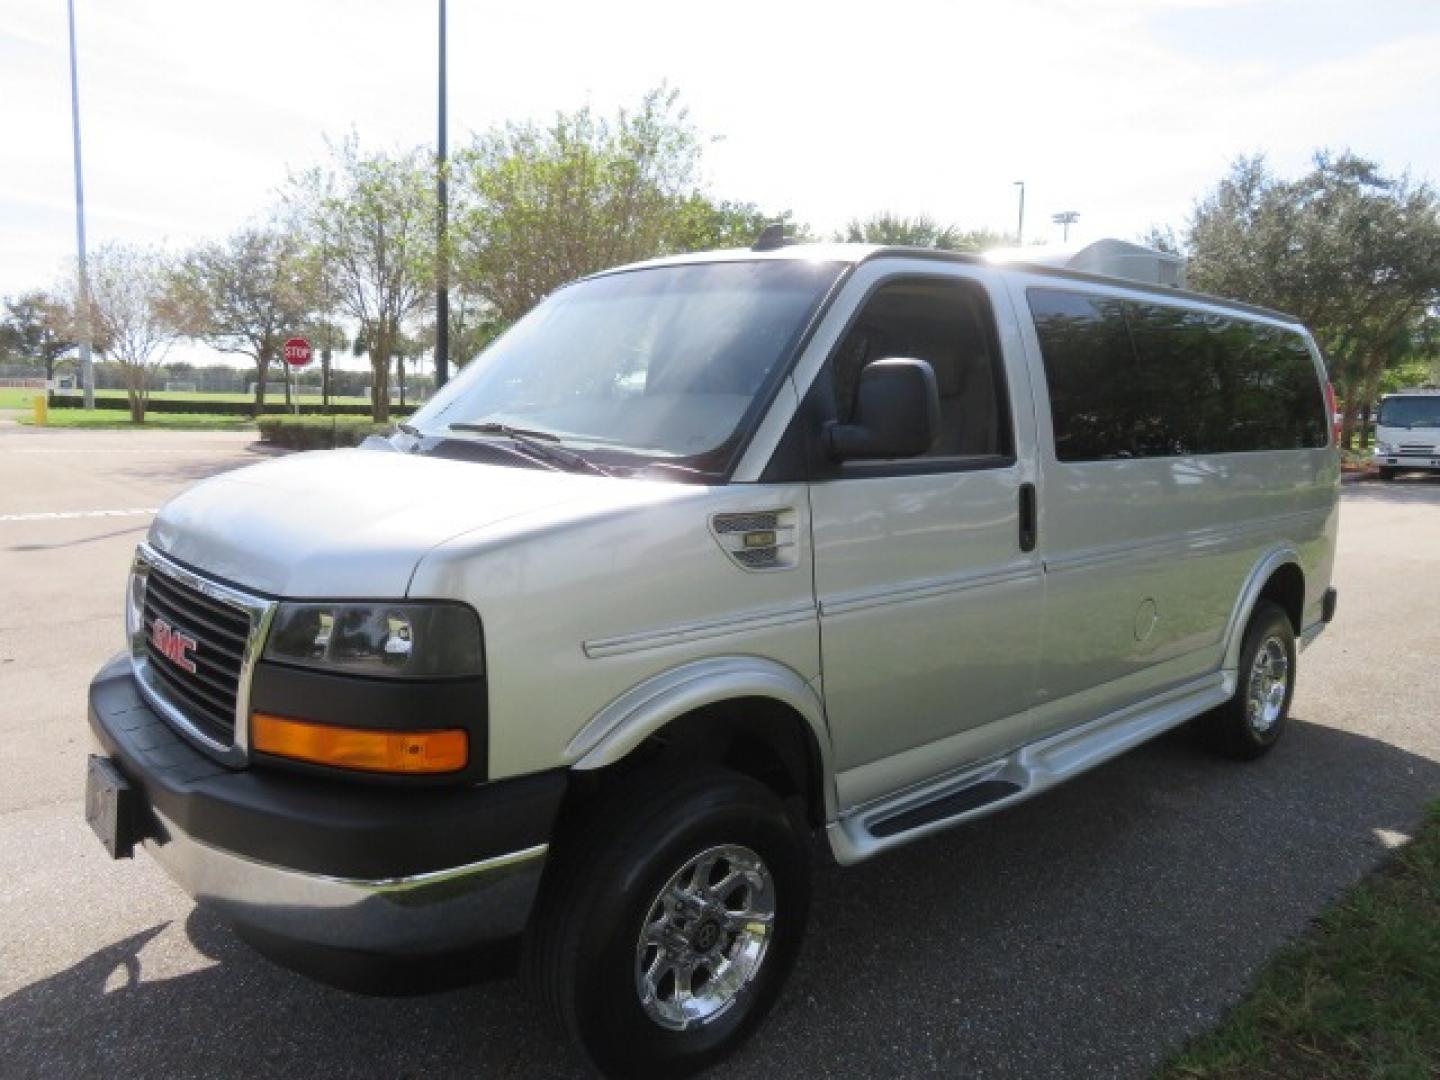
<box><xmin>827</xmin><ymin>357</ymin><xmax>940</xmax><ymax>461</ymax></box>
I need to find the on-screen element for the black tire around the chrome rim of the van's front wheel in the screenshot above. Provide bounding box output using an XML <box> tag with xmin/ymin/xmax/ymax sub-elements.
<box><xmin>521</xmin><ymin>768</ymin><xmax>811</xmax><ymax>1077</ymax></box>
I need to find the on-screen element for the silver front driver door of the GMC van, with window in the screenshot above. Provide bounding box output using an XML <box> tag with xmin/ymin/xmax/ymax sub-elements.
<box><xmin>811</xmin><ymin>264</ymin><xmax>1044</xmax><ymax>808</ymax></box>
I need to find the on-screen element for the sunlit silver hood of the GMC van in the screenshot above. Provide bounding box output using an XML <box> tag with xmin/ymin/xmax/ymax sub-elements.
<box><xmin>150</xmin><ymin>449</ymin><xmax>683</xmax><ymax>599</ymax></box>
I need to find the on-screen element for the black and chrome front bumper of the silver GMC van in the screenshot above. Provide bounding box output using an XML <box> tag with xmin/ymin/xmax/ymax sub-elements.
<box><xmin>89</xmin><ymin>657</ymin><xmax>566</xmax><ymax>955</ymax></box>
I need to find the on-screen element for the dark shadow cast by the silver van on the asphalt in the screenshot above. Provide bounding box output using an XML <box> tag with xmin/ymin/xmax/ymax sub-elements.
<box><xmin>0</xmin><ymin>723</ymin><xmax>1440</xmax><ymax>1080</ymax></box>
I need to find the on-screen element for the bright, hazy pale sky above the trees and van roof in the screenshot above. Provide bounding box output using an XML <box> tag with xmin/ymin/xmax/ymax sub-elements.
<box><xmin>0</xmin><ymin>0</ymin><xmax>1440</xmax><ymax>368</ymax></box>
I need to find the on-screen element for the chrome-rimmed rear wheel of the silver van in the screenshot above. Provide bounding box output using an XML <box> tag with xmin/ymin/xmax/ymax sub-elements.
<box><xmin>1202</xmin><ymin>600</ymin><xmax>1295</xmax><ymax>760</ymax></box>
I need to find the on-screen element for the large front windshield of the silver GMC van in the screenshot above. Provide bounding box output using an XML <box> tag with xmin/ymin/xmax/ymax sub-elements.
<box><xmin>413</xmin><ymin>259</ymin><xmax>842</xmax><ymax>471</ymax></box>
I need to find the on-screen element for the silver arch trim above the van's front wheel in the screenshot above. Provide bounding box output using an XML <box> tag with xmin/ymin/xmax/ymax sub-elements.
<box><xmin>564</xmin><ymin>657</ymin><xmax>837</xmax><ymax>821</ymax></box>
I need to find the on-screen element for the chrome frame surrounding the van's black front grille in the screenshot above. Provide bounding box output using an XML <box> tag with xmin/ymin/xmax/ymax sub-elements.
<box><xmin>125</xmin><ymin>543</ymin><xmax>279</xmax><ymax>766</ymax></box>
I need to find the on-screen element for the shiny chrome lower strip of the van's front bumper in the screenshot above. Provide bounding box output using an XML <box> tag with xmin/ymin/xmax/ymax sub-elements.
<box><xmin>143</xmin><ymin>812</ymin><xmax>549</xmax><ymax>956</ymax></box>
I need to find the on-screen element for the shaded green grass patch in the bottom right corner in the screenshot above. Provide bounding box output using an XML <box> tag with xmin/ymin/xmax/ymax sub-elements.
<box><xmin>1156</xmin><ymin>801</ymin><xmax>1440</xmax><ymax>1080</ymax></box>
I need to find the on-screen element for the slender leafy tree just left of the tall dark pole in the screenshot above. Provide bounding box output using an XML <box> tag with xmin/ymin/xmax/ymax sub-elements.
<box><xmin>291</xmin><ymin>137</ymin><xmax>435</xmax><ymax>423</ymax></box>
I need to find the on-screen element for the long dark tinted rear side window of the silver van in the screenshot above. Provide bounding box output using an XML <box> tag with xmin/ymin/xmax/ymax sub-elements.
<box><xmin>1030</xmin><ymin>289</ymin><xmax>1328</xmax><ymax>461</ymax></box>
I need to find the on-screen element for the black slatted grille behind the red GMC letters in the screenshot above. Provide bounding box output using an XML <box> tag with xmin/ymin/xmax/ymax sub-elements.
<box><xmin>144</xmin><ymin>570</ymin><xmax>251</xmax><ymax>743</ymax></box>
